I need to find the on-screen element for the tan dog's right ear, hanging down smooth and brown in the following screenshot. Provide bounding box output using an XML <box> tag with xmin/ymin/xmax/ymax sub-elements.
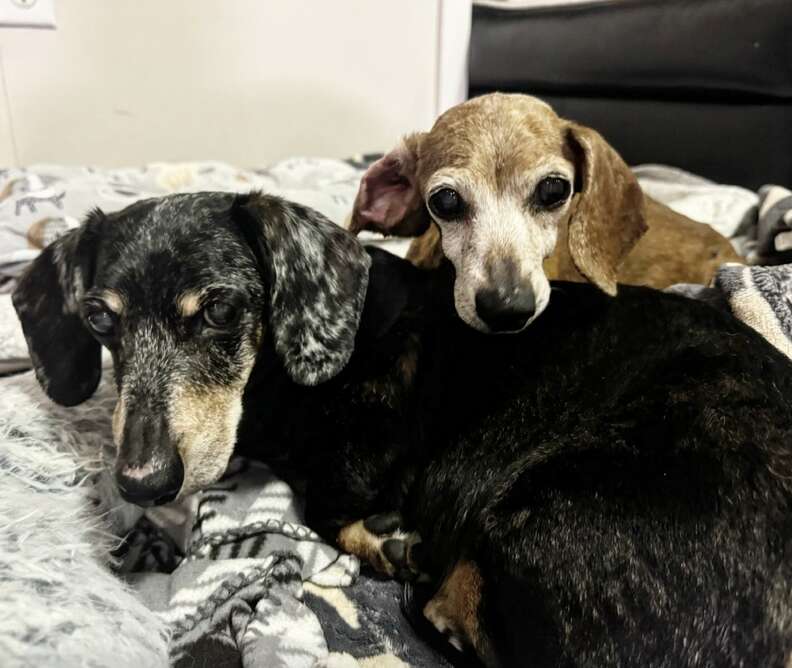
<box><xmin>567</xmin><ymin>123</ymin><xmax>647</xmax><ymax>295</ymax></box>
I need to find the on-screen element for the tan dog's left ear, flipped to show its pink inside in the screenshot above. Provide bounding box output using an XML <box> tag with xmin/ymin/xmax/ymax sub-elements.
<box><xmin>349</xmin><ymin>133</ymin><xmax>431</xmax><ymax>237</ymax></box>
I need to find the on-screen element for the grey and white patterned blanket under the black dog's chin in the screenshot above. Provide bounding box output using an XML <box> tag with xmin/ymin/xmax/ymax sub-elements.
<box><xmin>121</xmin><ymin>458</ymin><xmax>445</xmax><ymax>668</ymax></box>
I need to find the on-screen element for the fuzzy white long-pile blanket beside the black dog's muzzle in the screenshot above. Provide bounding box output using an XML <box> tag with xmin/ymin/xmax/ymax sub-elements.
<box><xmin>0</xmin><ymin>373</ymin><xmax>168</xmax><ymax>668</ymax></box>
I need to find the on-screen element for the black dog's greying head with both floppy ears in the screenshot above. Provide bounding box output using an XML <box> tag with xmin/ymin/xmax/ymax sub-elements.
<box><xmin>13</xmin><ymin>193</ymin><xmax>370</xmax><ymax>505</ymax></box>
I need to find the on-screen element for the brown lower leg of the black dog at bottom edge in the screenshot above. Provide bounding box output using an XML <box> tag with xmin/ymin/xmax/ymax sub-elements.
<box><xmin>423</xmin><ymin>561</ymin><xmax>497</xmax><ymax>666</ymax></box>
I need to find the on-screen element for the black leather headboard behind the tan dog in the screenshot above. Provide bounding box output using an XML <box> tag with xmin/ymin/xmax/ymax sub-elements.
<box><xmin>470</xmin><ymin>0</ymin><xmax>792</xmax><ymax>188</ymax></box>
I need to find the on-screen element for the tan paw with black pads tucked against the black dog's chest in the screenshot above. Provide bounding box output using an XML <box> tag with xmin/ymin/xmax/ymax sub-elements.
<box><xmin>338</xmin><ymin>512</ymin><xmax>422</xmax><ymax>581</ymax></box>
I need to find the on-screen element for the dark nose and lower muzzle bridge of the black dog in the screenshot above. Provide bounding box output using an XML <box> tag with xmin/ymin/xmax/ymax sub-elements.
<box><xmin>115</xmin><ymin>415</ymin><xmax>184</xmax><ymax>507</ymax></box>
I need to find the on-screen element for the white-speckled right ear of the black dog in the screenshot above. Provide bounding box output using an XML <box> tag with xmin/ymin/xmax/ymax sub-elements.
<box><xmin>232</xmin><ymin>193</ymin><xmax>370</xmax><ymax>385</ymax></box>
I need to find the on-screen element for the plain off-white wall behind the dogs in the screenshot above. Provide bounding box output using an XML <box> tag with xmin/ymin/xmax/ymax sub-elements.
<box><xmin>0</xmin><ymin>0</ymin><xmax>470</xmax><ymax>166</ymax></box>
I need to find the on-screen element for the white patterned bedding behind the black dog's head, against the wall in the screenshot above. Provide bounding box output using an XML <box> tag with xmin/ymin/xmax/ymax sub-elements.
<box><xmin>0</xmin><ymin>156</ymin><xmax>409</xmax><ymax>292</ymax></box>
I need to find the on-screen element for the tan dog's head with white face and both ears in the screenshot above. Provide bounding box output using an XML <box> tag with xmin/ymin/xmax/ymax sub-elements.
<box><xmin>350</xmin><ymin>94</ymin><xmax>646</xmax><ymax>332</ymax></box>
